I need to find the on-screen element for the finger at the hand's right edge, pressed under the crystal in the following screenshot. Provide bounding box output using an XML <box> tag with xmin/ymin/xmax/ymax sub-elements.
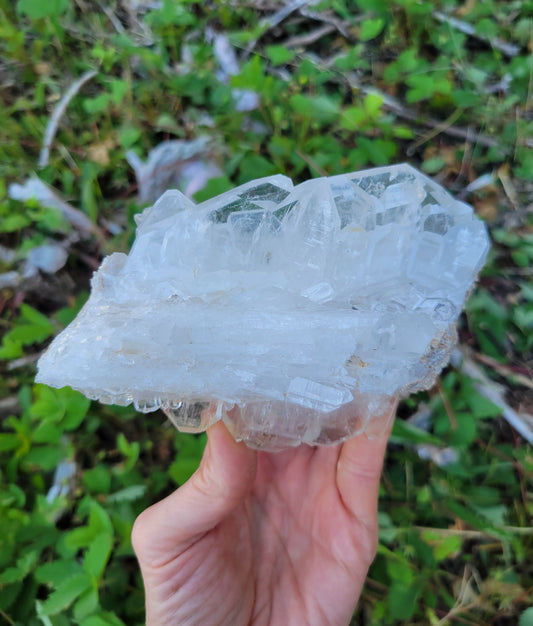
<box><xmin>337</xmin><ymin>401</ymin><xmax>397</xmax><ymax>528</ymax></box>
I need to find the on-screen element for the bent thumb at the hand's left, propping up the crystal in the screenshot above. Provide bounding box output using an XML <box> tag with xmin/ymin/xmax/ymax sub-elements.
<box><xmin>131</xmin><ymin>422</ymin><xmax>257</xmax><ymax>566</ymax></box>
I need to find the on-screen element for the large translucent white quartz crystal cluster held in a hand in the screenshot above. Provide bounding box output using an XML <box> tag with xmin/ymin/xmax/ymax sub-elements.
<box><xmin>37</xmin><ymin>165</ymin><xmax>489</xmax><ymax>450</ymax></box>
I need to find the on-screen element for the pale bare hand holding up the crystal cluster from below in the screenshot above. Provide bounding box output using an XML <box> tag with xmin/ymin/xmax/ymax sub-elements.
<box><xmin>132</xmin><ymin>404</ymin><xmax>388</xmax><ymax>626</ymax></box>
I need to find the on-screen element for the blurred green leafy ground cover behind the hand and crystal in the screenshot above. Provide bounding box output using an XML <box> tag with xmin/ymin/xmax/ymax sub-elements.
<box><xmin>0</xmin><ymin>0</ymin><xmax>533</xmax><ymax>626</ymax></box>
